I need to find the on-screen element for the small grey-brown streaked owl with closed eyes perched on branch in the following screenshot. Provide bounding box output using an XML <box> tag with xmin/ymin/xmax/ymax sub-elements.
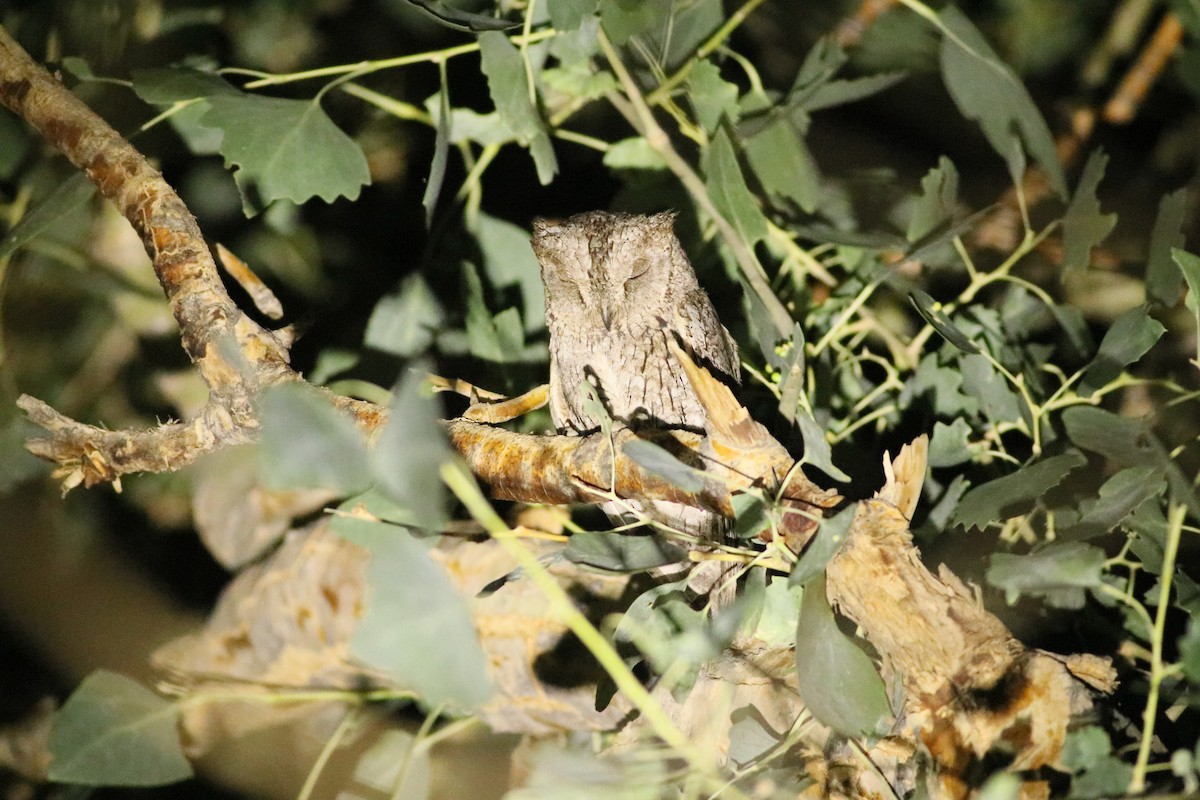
<box><xmin>533</xmin><ymin>211</ymin><xmax>739</xmax><ymax>536</ymax></box>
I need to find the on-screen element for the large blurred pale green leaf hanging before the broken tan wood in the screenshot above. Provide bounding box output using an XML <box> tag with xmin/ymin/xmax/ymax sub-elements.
<box><xmin>332</xmin><ymin>517</ymin><xmax>492</xmax><ymax>711</ymax></box>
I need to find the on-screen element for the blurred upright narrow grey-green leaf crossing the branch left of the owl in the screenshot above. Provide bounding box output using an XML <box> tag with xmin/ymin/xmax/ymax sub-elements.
<box><xmin>370</xmin><ymin>368</ymin><xmax>450</xmax><ymax>530</ymax></box>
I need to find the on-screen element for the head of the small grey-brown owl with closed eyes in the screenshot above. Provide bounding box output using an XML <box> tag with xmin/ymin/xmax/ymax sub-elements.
<box><xmin>533</xmin><ymin>211</ymin><xmax>695</xmax><ymax>331</ymax></box>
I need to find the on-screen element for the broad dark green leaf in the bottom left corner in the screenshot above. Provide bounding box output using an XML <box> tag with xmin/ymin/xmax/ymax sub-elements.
<box><xmin>49</xmin><ymin>669</ymin><xmax>192</xmax><ymax>786</ymax></box>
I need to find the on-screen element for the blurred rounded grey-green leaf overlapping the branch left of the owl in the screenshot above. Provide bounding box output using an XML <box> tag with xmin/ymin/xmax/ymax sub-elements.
<box><xmin>258</xmin><ymin>383</ymin><xmax>371</xmax><ymax>494</ymax></box>
